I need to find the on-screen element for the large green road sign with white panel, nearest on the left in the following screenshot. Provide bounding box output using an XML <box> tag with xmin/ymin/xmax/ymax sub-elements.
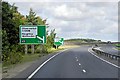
<box><xmin>19</xmin><ymin>25</ymin><xmax>46</xmax><ymax>44</ymax></box>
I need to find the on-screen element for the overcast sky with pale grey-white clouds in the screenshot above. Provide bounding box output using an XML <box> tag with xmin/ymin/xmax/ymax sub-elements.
<box><xmin>4</xmin><ymin>0</ymin><xmax>118</xmax><ymax>41</ymax></box>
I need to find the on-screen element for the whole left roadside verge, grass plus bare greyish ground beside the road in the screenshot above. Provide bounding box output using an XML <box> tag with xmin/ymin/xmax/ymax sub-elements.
<box><xmin>1</xmin><ymin>45</ymin><xmax>77</xmax><ymax>78</ymax></box>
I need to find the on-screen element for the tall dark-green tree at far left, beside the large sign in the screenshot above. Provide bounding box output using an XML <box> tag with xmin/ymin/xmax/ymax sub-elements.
<box><xmin>2</xmin><ymin>2</ymin><xmax>21</xmax><ymax>63</ymax></box>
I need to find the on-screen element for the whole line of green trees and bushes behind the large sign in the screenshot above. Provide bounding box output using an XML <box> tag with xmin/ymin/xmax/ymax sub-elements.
<box><xmin>2</xmin><ymin>1</ymin><xmax>56</xmax><ymax>64</ymax></box>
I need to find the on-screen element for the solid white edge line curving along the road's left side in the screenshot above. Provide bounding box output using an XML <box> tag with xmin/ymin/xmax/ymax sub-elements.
<box><xmin>26</xmin><ymin>49</ymin><xmax>67</xmax><ymax>80</ymax></box>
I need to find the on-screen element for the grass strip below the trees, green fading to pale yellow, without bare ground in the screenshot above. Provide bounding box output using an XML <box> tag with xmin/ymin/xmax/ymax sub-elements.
<box><xmin>3</xmin><ymin>45</ymin><xmax>78</xmax><ymax>68</ymax></box>
